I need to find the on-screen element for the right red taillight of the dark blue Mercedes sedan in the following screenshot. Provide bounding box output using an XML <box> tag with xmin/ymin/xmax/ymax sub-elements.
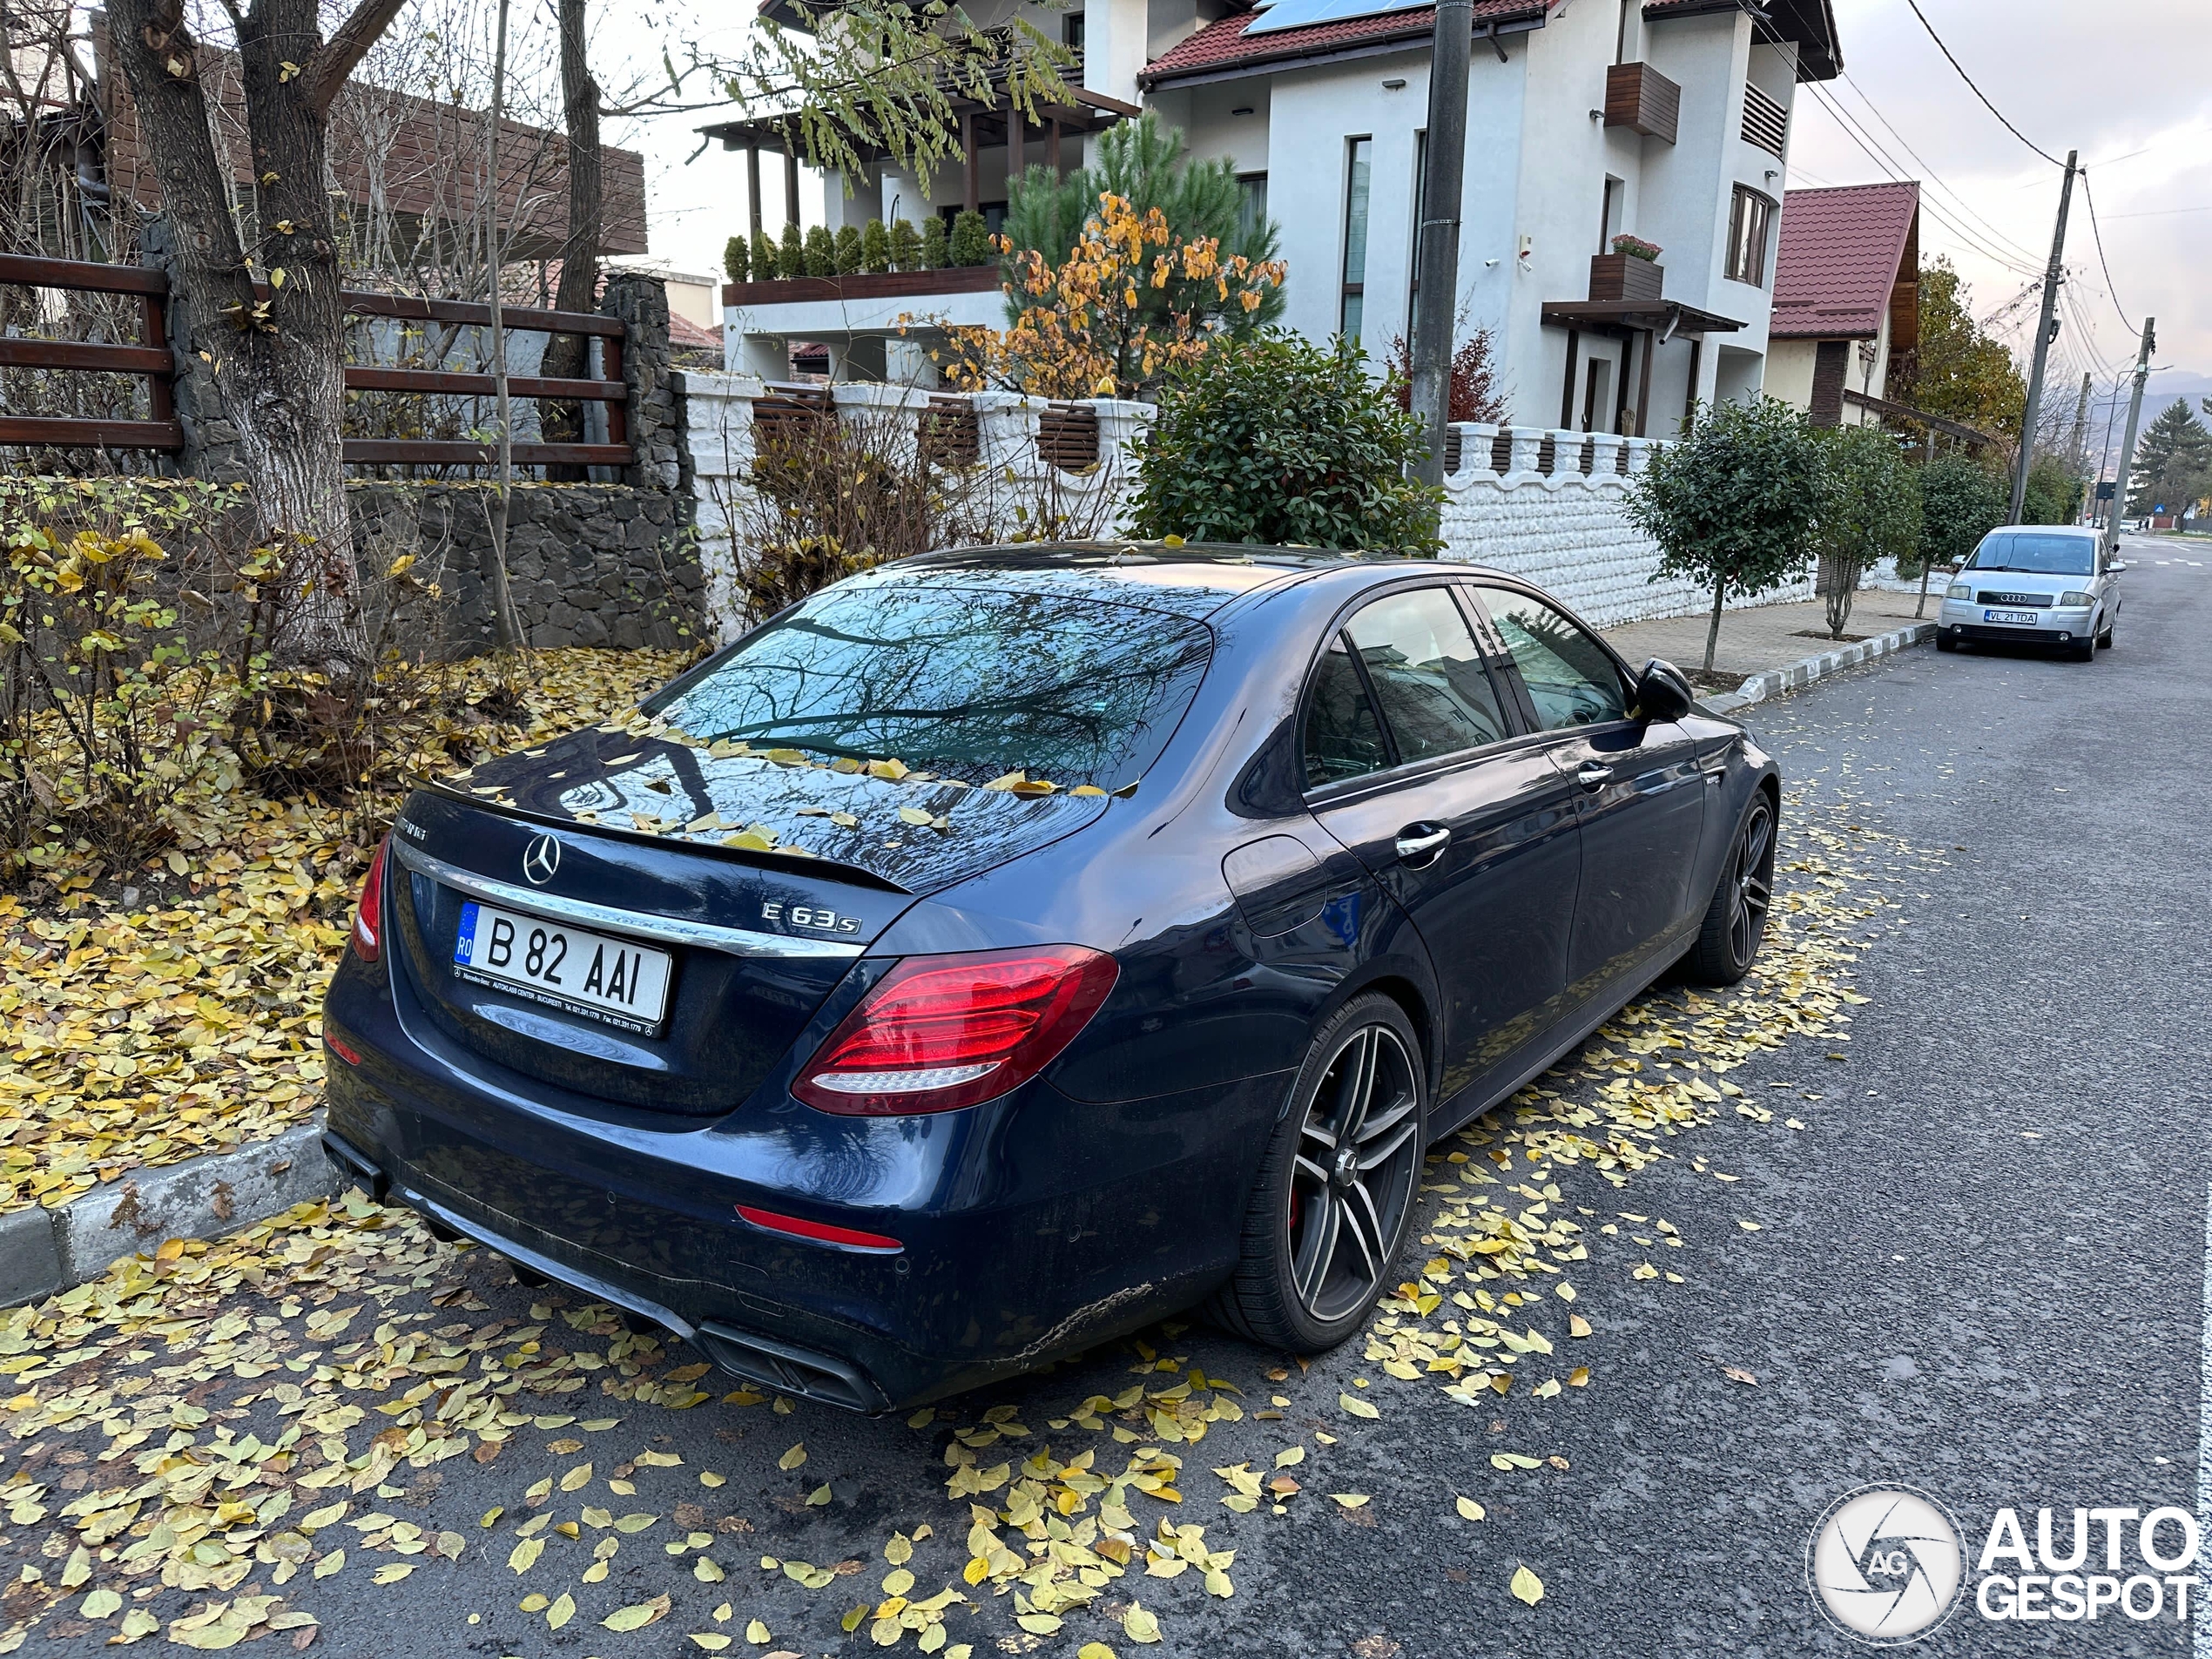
<box><xmin>792</xmin><ymin>945</ymin><xmax>1117</xmax><ymax>1117</ymax></box>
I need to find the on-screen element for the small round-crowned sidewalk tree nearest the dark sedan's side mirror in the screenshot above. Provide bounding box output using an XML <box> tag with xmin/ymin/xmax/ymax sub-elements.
<box><xmin>1622</xmin><ymin>398</ymin><xmax>1825</xmax><ymax>675</ymax></box>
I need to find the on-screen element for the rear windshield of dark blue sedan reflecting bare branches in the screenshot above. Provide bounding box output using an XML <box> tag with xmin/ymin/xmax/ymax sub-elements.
<box><xmin>648</xmin><ymin>579</ymin><xmax>1212</xmax><ymax>790</ymax></box>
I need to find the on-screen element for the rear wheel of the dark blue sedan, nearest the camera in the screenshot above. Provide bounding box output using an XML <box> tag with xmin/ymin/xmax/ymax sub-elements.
<box><xmin>1205</xmin><ymin>993</ymin><xmax>1429</xmax><ymax>1353</ymax></box>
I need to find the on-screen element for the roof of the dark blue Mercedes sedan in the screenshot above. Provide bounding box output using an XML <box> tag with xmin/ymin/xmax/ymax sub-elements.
<box><xmin>876</xmin><ymin>540</ymin><xmax>1513</xmax><ymax>617</ymax></box>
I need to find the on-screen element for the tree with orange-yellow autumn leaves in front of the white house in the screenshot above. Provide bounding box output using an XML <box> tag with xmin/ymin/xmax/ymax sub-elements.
<box><xmin>938</xmin><ymin>190</ymin><xmax>1285</xmax><ymax>398</ymax></box>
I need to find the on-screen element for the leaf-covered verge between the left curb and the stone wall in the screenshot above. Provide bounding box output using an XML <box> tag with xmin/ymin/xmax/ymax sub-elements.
<box><xmin>0</xmin><ymin>651</ymin><xmax>684</xmax><ymax>1210</ymax></box>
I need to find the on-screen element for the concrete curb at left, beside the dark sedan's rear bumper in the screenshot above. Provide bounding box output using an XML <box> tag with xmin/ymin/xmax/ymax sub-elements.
<box><xmin>0</xmin><ymin>1113</ymin><xmax>345</xmax><ymax>1307</ymax></box>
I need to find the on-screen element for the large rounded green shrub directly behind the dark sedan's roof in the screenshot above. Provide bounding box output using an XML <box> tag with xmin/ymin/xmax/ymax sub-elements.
<box><xmin>1132</xmin><ymin>334</ymin><xmax>1445</xmax><ymax>556</ymax></box>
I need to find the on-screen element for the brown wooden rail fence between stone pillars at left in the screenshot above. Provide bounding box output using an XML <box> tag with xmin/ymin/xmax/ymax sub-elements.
<box><xmin>0</xmin><ymin>254</ymin><xmax>637</xmax><ymax>467</ymax></box>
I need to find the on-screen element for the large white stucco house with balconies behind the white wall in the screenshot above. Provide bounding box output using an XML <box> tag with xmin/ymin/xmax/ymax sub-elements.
<box><xmin>710</xmin><ymin>0</ymin><xmax>1840</xmax><ymax>435</ymax></box>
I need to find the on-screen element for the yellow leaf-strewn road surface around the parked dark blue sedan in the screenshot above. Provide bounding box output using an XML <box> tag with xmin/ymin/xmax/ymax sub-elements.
<box><xmin>0</xmin><ymin>806</ymin><xmax>1926</xmax><ymax>1659</ymax></box>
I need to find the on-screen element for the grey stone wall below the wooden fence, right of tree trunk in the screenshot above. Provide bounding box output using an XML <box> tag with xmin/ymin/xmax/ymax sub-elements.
<box><xmin>347</xmin><ymin>480</ymin><xmax>704</xmax><ymax>657</ymax></box>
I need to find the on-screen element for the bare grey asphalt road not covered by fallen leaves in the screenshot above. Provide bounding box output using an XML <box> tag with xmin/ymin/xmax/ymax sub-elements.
<box><xmin>0</xmin><ymin>542</ymin><xmax>2212</xmax><ymax>1659</ymax></box>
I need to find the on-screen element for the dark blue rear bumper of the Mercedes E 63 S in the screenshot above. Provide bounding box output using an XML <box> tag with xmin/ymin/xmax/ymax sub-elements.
<box><xmin>325</xmin><ymin>958</ymin><xmax>1290</xmax><ymax>1412</ymax></box>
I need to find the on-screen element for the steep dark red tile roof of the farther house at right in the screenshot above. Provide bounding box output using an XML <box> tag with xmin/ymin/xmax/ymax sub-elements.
<box><xmin>1770</xmin><ymin>184</ymin><xmax>1920</xmax><ymax>341</ymax></box>
